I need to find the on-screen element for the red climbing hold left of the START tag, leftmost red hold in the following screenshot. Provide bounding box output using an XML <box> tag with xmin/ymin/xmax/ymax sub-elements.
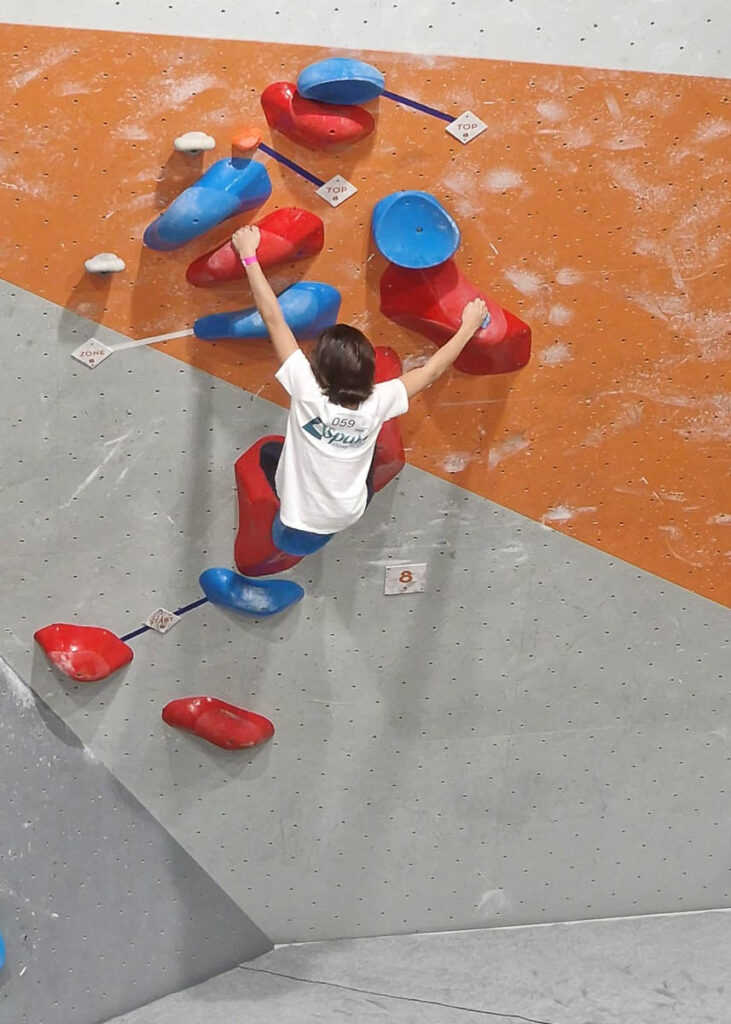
<box><xmin>34</xmin><ymin>623</ymin><xmax>134</xmax><ymax>683</ymax></box>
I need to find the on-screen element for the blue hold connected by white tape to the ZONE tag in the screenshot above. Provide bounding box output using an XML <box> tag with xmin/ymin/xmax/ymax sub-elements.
<box><xmin>192</xmin><ymin>281</ymin><xmax>341</xmax><ymax>341</ymax></box>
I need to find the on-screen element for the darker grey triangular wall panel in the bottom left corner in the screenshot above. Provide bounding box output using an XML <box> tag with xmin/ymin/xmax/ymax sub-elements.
<box><xmin>0</xmin><ymin>659</ymin><xmax>270</xmax><ymax>1024</ymax></box>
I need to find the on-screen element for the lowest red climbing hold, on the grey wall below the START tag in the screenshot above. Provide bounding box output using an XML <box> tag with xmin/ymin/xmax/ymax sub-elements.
<box><xmin>163</xmin><ymin>697</ymin><xmax>274</xmax><ymax>751</ymax></box>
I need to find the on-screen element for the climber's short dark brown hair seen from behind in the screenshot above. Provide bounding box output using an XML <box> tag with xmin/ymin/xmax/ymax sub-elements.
<box><xmin>312</xmin><ymin>324</ymin><xmax>376</xmax><ymax>409</ymax></box>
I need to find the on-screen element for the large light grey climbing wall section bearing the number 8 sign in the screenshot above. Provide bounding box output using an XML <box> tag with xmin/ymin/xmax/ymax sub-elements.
<box><xmin>0</xmin><ymin>276</ymin><xmax>731</xmax><ymax>941</ymax></box>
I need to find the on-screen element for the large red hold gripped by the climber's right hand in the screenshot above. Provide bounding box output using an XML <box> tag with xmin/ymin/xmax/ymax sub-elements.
<box><xmin>381</xmin><ymin>259</ymin><xmax>530</xmax><ymax>374</ymax></box>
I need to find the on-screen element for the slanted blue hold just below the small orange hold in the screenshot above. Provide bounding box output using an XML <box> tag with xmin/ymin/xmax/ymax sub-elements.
<box><xmin>143</xmin><ymin>157</ymin><xmax>271</xmax><ymax>251</ymax></box>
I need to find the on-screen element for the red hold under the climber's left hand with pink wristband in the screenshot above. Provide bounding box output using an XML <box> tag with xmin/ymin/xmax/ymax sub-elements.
<box><xmin>185</xmin><ymin>206</ymin><xmax>325</xmax><ymax>288</ymax></box>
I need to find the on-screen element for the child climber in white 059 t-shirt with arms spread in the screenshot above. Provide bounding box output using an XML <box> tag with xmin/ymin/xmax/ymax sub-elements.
<box><xmin>232</xmin><ymin>226</ymin><xmax>487</xmax><ymax>554</ymax></box>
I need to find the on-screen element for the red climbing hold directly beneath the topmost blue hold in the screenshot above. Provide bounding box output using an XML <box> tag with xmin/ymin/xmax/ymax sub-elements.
<box><xmin>261</xmin><ymin>82</ymin><xmax>376</xmax><ymax>150</ymax></box>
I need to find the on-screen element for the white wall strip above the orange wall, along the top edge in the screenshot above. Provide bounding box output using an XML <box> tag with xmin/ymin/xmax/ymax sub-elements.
<box><xmin>2</xmin><ymin>0</ymin><xmax>729</xmax><ymax>75</ymax></box>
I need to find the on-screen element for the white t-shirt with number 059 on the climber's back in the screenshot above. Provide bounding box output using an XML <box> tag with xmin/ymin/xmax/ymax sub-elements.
<box><xmin>276</xmin><ymin>349</ymin><xmax>409</xmax><ymax>534</ymax></box>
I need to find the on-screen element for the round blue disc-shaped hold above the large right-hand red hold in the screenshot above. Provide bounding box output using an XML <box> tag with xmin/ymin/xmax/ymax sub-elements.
<box><xmin>373</xmin><ymin>191</ymin><xmax>460</xmax><ymax>270</ymax></box>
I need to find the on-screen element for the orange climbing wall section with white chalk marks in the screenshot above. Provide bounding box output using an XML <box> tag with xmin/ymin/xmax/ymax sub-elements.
<box><xmin>0</xmin><ymin>26</ymin><xmax>731</xmax><ymax>601</ymax></box>
